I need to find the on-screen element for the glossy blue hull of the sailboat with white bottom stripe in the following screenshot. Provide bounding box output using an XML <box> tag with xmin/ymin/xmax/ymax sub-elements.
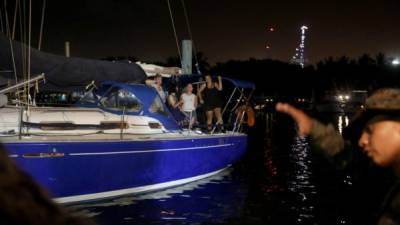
<box><xmin>4</xmin><ymin>135</ymin><xmax>247</xmax><ymax>202</ymax></box>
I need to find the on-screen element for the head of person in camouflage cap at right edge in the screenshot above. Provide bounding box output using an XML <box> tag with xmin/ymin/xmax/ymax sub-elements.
<box><xmin>344</xmin><ymin>88</ymin><xmax>400</xmax><ymax>166</ymax></box>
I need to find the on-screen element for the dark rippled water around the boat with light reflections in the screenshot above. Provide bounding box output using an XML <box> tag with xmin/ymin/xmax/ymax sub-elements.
<box><xmin>68</xmin><ymin>113</ymin><xmax>392</xmax><ymax>225</ymax></box>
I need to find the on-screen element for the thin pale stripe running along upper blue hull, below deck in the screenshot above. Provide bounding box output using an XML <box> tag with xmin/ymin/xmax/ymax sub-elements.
<box><xmin>69</xmin><ymin>144</ymin><xmax>234</xmax><ymax>156</ymax></box>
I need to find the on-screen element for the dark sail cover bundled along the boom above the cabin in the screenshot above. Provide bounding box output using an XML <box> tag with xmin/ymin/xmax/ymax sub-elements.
<box><xmin>0</xmin><ymin>33</ymin><xmax>146</xmax><ymax>90</ymax></box>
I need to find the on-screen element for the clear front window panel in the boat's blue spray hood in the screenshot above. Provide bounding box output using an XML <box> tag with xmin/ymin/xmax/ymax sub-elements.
<box><xmin>100</xmin><ymin>88</ymin><xmax>143</xmax><ymax>112</ymax></box>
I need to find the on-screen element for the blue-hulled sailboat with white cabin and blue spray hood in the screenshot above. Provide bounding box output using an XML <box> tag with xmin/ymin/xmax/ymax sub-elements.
<box><xmin>0</xmin><ymin>35</ymin><xmax>254</xmax><ymax>203</ymax></box>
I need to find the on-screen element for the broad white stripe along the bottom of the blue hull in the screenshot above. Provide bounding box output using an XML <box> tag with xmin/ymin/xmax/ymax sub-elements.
<box><xmin>54</xmin><ymin>165</ymin><xmax>230</xmax><ymax>203</ymax></box>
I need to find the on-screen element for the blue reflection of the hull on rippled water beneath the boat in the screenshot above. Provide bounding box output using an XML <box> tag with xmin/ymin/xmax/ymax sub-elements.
<box><xmin>68</xmin><ymin>170</ymin><xmax>247</xmax><ymax>225</ymax></box>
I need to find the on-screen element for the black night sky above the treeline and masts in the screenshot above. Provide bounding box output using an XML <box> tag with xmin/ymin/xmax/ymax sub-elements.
<box><xmin>21</xmin><ymin>0</ymin><xmax>400</xmax><ymax>63</ymax></box>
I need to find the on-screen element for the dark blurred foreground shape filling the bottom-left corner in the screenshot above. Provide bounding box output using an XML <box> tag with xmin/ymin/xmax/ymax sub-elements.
<box><xmin>0</xmin><ymin>145</ymin><xmax>92</xmax><ymax>225</ymax></box>
